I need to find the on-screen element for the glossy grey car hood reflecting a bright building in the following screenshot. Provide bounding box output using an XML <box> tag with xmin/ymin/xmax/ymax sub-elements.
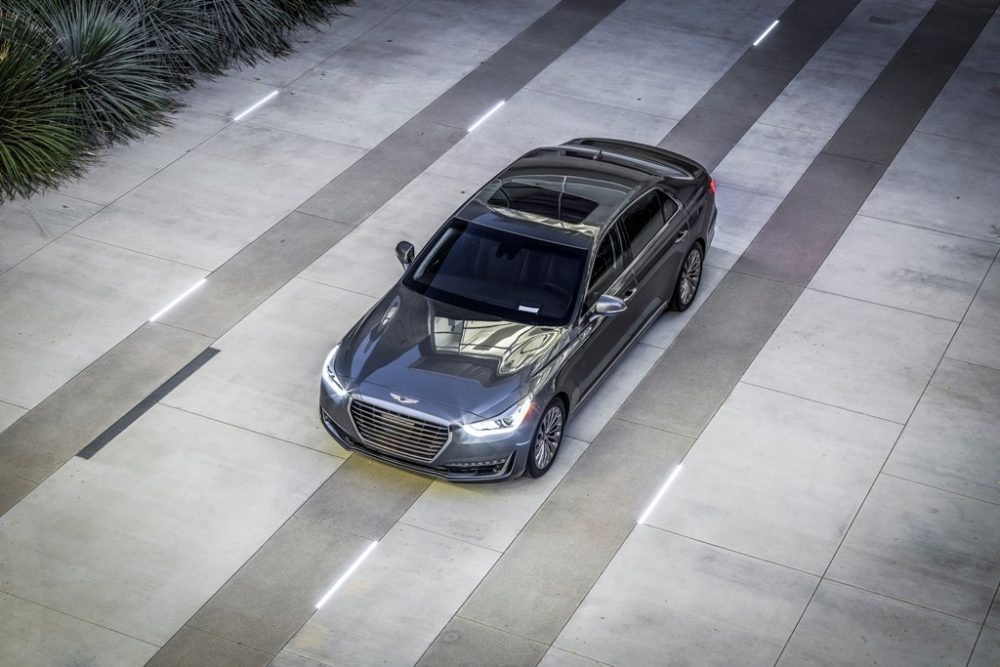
<box><xmin>336</xmin><ymin>284</ymin><xmax>565</xmax><ymax>419</ymax></box>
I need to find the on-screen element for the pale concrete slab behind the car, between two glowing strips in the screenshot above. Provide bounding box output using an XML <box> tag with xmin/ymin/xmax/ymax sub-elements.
<box><xmin>527</xmin><ymin>19</ymin><xmax>747</xmax><ymax>120</ymax></box>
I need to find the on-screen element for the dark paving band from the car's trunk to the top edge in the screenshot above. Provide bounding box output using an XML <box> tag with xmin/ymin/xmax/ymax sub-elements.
<box><xmin>660</xmin><ymin>0</ymin><xmax>858</xmax><ymax>170</ymax></box>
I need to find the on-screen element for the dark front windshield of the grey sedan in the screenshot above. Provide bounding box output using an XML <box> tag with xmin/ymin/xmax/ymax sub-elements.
<box><xmin>403</xmin><ymin>220</ymin><xmax>587</xmax><ymax>325</ymax></box>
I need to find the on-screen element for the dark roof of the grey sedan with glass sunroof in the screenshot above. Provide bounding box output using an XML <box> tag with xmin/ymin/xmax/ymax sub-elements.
<box><xmin>456</xmin><ymin>139</ymin><xmax>704</xmax><ymax>247</ymax></box>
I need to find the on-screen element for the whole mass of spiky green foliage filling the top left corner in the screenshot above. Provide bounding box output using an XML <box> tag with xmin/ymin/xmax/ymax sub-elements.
<box><xmin>0</xmin><ymin>0</ymin><xmax>351</xmax><ymax>203</ymax></box>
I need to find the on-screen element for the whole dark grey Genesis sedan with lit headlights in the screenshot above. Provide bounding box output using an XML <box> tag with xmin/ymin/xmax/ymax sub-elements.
<box><xmin>320</xmin><ymin>138</ymin><xmax>716</xmax><ymax>482</ymax></box>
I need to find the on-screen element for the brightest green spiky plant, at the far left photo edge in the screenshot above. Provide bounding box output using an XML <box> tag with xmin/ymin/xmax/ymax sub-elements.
<box><xmin>0</xmin><ymin>9</ymin><xmax>89</xmax><ymax>202</ymax></box>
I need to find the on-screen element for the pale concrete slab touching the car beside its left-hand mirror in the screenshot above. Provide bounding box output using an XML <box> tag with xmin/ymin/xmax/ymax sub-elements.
<box><xmin>299</xmin><ymin>171</ymin><xmax>479</xmax><ymax>298</ymax></box>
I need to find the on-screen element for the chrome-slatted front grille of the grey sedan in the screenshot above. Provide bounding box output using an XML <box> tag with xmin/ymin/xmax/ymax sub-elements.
<box><xmin>351</xmin><ymin>399</ymin><xmax>448</xmax><ymax>463</ymax></box>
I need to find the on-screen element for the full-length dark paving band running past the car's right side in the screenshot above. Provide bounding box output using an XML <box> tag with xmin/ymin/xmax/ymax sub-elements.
<box><xmin>422</xmin><ymin>0</ymin><xmax>997</xmax><ymax>665</ymax></box>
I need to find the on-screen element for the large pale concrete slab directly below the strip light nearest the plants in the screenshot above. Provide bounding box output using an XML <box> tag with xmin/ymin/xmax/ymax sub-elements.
<box><xmin>75</xmin><ymin>122</ymin><xmax>363</xmax><ymax>270</ymax></box>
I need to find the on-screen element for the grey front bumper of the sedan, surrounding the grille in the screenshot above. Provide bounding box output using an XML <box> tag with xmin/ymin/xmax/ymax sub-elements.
<box><xmin>319</xmin><ymin>382</ymin><xmax>535</xmax><ymax>483</ymax></box>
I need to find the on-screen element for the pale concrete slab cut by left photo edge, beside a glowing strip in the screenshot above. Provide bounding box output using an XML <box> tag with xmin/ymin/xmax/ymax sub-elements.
<box><xmin>0</xmin><ymin>234</ymin><xmax>205</xmax><ymax>408</ymax></box>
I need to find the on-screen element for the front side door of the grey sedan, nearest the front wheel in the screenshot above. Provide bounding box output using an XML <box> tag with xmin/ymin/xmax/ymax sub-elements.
<box><xmin>560</xmin><ymin>224</ymin><xmax>635</xmax><ymax>406</ymax></box>
